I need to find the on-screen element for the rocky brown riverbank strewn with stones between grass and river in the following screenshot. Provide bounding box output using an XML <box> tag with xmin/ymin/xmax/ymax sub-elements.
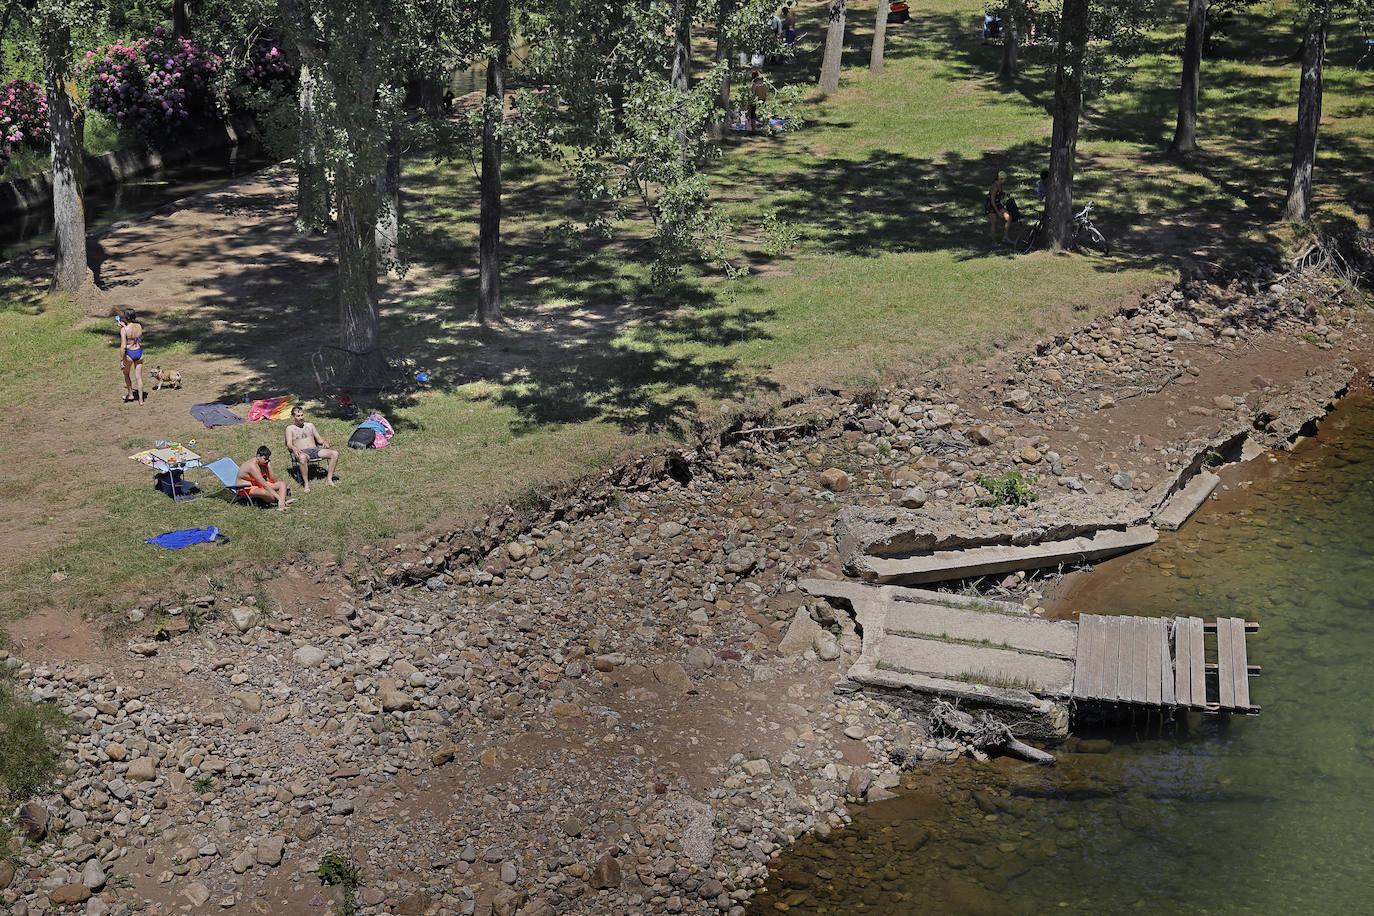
<box><xmin>0</xmin><ymin>252</ymin><xmax>1374</xmax><ymax>916</ymax></box>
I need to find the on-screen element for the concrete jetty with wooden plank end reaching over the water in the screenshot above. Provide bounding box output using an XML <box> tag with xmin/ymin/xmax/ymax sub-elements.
<box><xmin>798</xmin><ymin>580</ymin><xmax>1259</xmax><ymax>714</ymax></box>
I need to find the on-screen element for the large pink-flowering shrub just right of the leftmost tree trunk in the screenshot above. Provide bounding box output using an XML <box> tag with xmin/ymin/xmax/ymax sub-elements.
<box><xmin>77</xmin><ymin>26</ymin><xmax>224</xmax><ymax>139</ymax></box>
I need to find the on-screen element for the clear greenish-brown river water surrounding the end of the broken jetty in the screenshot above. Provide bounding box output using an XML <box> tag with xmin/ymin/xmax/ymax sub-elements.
<box><xmin>750</xmin><ymin>398</ymin><xmax>1374</xmax><ymax>915</ymax></box>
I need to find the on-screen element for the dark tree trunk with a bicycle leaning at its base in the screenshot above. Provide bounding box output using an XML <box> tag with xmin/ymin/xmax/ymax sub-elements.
<box><xmin>1044</xmin><ymin>0</ymin><xmax>1088</xmax><ymax>251</ymax></box>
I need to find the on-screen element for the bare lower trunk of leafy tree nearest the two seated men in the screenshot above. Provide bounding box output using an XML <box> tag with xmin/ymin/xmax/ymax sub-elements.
<box><xmin>337</xmin><ymin>184</ymin><xmax>381</xmax><ymax>353</ymax></box>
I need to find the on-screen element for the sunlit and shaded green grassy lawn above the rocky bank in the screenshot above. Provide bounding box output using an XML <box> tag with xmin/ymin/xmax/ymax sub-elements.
<box><xmin>0</xmin><ymin>0</ymin><xmax>1374</xmax><ymax>631</ymax></box>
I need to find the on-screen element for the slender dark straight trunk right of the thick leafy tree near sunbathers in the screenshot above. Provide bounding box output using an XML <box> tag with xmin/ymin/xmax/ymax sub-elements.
<box><xmin>477</xmin><ymin>0</ymin><xmax>510</xmax><ymax>324</ymax></box>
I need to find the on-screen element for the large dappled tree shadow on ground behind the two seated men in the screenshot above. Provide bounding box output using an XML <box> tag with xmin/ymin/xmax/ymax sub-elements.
<box><xmin>83</xmin><ymin>164</ymin><xmax>775</xmax><ymax>444</ymax></box>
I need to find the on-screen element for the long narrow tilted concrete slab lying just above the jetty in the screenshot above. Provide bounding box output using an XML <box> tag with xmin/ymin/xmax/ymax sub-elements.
<box><xmin>851</xmin><ymin>525</ymin><xmax>1160</xmax><ymax>585</ymax></box>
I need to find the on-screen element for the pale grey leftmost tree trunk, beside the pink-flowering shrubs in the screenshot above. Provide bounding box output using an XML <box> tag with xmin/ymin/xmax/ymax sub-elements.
<box><xmin>43</xmin><ymin>23</ymin><xmax>87</xmax><ymax>295</ymax></box>
